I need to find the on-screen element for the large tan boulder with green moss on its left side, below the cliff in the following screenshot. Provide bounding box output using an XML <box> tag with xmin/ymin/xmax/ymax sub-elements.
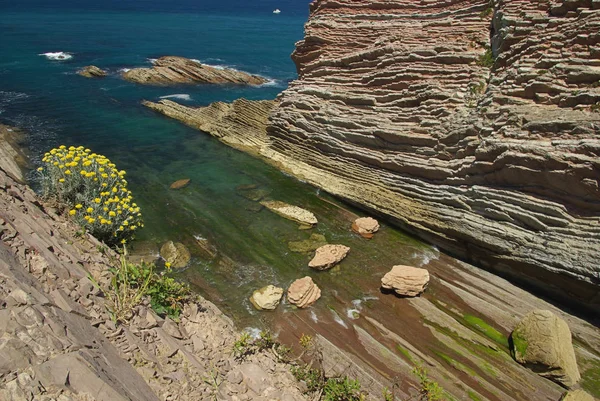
<box><xmin>511</xmin><ymin>310</ymin><xmax>581</xmax><ymax>387</ymax></box>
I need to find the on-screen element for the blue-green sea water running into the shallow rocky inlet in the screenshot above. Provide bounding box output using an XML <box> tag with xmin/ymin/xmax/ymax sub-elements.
<box><xmin>0</xmin><ymin>0</ymin><xmax>439</xmax><ymax>337</ymax></box>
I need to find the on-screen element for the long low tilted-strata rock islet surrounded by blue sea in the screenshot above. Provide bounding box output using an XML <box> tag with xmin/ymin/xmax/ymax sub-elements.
<box><xmin>123</xmin><ymin>56</ymin><xmax>267</xmax><ymax>85</ymax></box>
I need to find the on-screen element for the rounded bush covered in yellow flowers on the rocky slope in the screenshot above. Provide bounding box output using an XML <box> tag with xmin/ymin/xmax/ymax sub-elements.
<box><xmin>38</xmin><ymin>145</ymin><xmax>144</xmax><ymax>244</ymax></box>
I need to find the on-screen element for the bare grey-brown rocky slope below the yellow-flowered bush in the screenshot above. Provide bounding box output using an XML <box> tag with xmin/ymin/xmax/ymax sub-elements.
<box><xmin>0</xmin><ymin>137</ymin><xmax>306</xmax><ymax>401</ymax></box>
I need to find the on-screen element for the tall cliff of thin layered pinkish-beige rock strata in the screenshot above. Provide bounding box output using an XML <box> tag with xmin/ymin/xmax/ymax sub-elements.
<box><xmin>262</xmin><ymin>0</ymin><xmax>600</xmax><ymax>306</ymax></box>
